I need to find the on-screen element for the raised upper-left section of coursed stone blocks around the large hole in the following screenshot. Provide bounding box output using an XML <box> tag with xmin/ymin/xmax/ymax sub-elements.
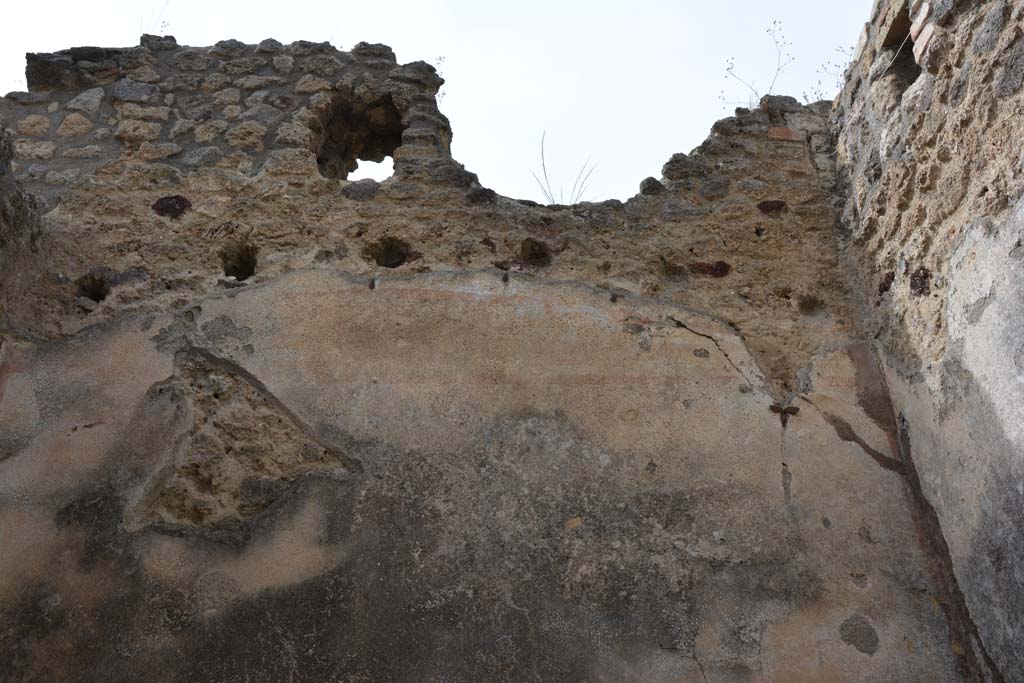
<box><xmin>3</xmin><ymin>36</ymin><xmax>460</xmax><ymax>198</ymax></box>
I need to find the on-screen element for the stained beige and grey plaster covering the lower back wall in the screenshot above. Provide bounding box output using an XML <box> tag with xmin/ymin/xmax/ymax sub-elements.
<box><xmin>0</xmin><ymin>268</ymin><xmax>953</xmax><ymax>681</ymax></box>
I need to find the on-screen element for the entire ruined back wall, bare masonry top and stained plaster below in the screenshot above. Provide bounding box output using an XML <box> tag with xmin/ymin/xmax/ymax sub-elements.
<box><xmin>0</xmin><ymin>25</ymin><xmax>999</xmax><ymax>683</ymax></box>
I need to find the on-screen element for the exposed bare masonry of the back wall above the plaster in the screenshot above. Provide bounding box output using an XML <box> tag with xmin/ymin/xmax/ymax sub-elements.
<box><xmin>0</xmin><ymin>37</ymin><xmax>847</xmax><ymax>395</ymax></box>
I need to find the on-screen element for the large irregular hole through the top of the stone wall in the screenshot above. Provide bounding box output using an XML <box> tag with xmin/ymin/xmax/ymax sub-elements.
<box><xmin>316</xmin><ymin>95</ymin><xmax>406</xmax><ymax>180</ymax></box>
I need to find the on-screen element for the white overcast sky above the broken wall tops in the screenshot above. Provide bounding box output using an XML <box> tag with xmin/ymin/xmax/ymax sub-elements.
<box><xmin>0</xmin><ymin>0</ymin><xmax>871</xmax><ymax>200</ymax></box>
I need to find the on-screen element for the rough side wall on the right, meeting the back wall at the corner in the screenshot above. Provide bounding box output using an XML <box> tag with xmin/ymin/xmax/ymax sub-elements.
<box><xmin>835</xmin><ymin>0</ymin><xmax>1024</xmax><ymax>681</ymax></box>
